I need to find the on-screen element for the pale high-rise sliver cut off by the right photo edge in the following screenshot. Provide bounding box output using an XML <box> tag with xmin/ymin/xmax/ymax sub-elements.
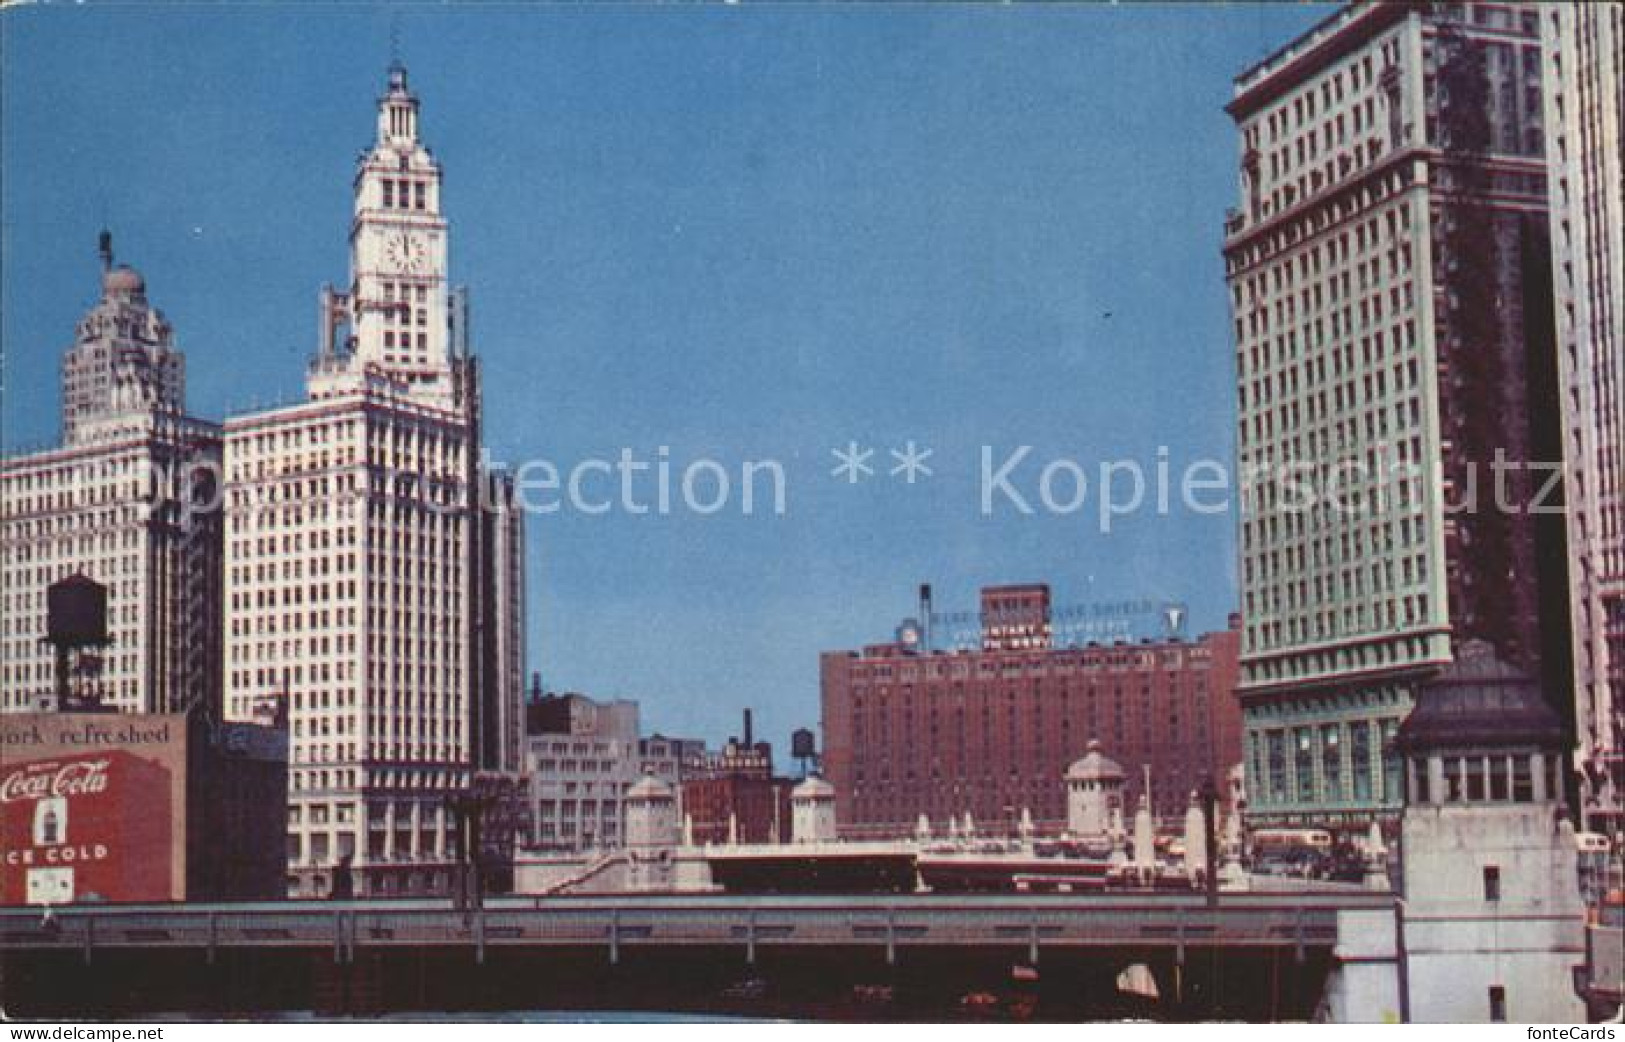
<box><xmin>1541</xmin><ymin>3</ymin><xmax>1625</xmax><ymax>831</ymax></box>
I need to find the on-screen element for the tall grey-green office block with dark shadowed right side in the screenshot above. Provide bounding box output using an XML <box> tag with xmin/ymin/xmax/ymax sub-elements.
<box><xmin>1224</xmin><ymin>3</ymin><xmax>1570</xmax><ymax>827</ymax></box>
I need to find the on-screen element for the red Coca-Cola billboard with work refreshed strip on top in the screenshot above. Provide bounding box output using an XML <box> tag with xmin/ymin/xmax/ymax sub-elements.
<box><xmin>0</xmin><ymin>714</ymin><xmax>187</xmax><ymax>905</ymax></box>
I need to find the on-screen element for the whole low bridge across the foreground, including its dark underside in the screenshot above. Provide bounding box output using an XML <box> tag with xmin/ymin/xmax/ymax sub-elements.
<box><xmin>0</xmin><ymin>889</ymin><xmax>1399</xmax><ymax>1019</ymax></box>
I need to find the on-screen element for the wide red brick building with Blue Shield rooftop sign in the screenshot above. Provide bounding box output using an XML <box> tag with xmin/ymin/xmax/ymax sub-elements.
<box><xmin>821</xmin><ymin>585</ymin><xmax>1242</xmax><ymax>836</ymax></box>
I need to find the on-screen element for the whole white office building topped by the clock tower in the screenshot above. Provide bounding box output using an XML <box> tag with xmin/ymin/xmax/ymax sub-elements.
<box><xmin>224</xmin><ymin>65</ymin><xmax>523</xmax><ymax>894</ymax></box>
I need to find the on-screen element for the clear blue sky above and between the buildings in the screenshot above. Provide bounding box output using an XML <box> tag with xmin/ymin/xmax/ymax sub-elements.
<box><xmin>0</xmin><ymin>5</ymin><xmax>1326</xmax><ymax>748</ymax></box>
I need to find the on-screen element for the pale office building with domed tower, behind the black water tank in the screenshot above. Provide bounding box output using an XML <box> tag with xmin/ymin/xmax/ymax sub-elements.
<box><xmin>0</xmin><ymin>240</ymin><xmax>221</xmax><ymax>712</ymax></box>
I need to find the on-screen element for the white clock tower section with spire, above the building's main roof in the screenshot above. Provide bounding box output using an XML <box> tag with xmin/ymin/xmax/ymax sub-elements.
<box><xmin>310</xmin><ymin>56</ymin><xmax>457</xmax><ymax>405</ymax></box>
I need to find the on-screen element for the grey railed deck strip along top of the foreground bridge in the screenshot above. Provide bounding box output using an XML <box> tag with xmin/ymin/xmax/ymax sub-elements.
<box><xmin>0</xmin><ymin>891</ymin><xmax>1393</xmax><ymax>961</ymax></box>
